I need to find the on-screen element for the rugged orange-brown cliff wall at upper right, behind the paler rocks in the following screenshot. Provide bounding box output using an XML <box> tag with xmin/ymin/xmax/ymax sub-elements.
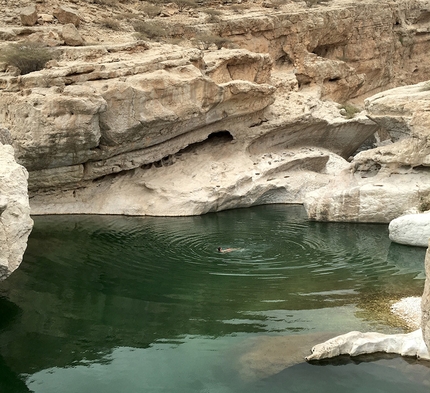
<box><xmin>192</xmin><ymin>0</ymin><xmax>430</xmax><ymax>102</ymax></box>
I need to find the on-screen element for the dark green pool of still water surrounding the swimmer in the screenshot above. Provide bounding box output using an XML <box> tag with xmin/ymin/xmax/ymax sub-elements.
<box><xmin>0</xmin><ymin>205</ymin><xmax>430</xmax><ymax>393</ymax></box>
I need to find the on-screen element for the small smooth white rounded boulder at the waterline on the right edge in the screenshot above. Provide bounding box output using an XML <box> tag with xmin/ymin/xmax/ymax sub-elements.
<box><xmin>388</xmin><ymin>214</ymin><xmax>430</xmax><ymax>247</ymax></box>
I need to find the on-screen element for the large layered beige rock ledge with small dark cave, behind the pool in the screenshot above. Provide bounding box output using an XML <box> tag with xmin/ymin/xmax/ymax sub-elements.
<box><xmin>0</xmin><ymin>36</ymin><xmax>376</xmax><ymax>215</ymax></box>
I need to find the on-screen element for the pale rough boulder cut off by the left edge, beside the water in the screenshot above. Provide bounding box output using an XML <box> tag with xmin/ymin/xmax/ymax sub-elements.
<box><xmin>0</xmin><ymin>143</ymin><xmax>33</xmax><ymax>280</ymax></box>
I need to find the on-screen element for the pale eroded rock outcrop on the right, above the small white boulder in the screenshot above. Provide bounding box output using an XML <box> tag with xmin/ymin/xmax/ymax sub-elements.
<box><xmin>305</xmin><ymin>82</ymin><xmax>430</xmax><ymax>223</ymax></box>
